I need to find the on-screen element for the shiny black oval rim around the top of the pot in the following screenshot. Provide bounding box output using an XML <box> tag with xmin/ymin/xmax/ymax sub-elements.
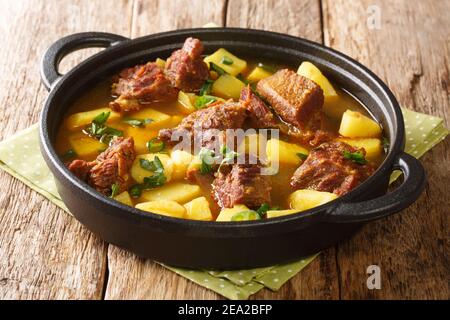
<box><xmin>39</xmin><ymin>27</ymin><xmax>404</xmax><ymax>232</ymax></box>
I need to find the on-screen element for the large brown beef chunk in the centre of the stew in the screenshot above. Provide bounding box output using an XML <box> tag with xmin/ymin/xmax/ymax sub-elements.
<box><xmin>159</xmin><ymin>102</ymin><xmax>247</xmax><ymax>150</ymax></box>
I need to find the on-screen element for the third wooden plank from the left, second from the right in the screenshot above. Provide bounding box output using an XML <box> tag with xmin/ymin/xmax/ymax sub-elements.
<box><xmin>227</xmin><ymin>0</ymin><xmax>339</xmax><ymax>299</ymax></box>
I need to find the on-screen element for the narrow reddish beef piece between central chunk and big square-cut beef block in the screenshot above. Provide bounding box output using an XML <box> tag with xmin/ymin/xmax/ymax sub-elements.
<box><xmin>239</xmin><ymin>86</ymin><xmax>279</xmax><ymax>129</ymax></box>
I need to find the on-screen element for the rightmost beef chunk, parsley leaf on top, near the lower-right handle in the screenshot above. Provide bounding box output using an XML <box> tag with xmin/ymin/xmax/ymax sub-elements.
<box><xmin>291</xmin><ymin>142</ymin><xmax>373</xmax><ymax>195</ymax></box>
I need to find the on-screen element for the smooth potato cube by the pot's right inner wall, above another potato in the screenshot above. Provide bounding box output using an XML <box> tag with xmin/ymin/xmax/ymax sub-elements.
<box><xmin>339</xmin><ymin>110</ymin><xmax>381</xmax><ymax>138</ymax></box>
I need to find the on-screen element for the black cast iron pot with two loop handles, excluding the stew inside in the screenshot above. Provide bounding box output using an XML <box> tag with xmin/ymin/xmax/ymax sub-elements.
<box><xmin>40</xmin><ymin>28</ymin><xmax>425</xmax><ymax>269</ymax></box>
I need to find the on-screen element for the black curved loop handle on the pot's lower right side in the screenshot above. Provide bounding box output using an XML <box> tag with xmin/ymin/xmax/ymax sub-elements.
<box><xmin>323</xmin><ymin>153</ymin><xmax>426</xmax><ymax>223</ymax></box>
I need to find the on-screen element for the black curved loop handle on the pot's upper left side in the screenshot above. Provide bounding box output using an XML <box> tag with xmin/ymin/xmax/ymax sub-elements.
<box><xmin>41</xmin><ymin>32</ymin><xmax>129</xmax><ymax>90</ymax></box>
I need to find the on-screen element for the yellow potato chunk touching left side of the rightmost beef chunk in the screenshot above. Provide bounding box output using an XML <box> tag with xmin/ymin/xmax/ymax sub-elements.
<box><xmin>266</xmin><ymin>139</ymin><xmax>309</xmax><ymax>165</ymax></box>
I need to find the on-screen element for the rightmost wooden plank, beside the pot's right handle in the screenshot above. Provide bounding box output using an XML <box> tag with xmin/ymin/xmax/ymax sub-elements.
<box><xmin>323</xmin><ymin>0</ymin><xmax>450</xmax><ymax>299</ymax></box>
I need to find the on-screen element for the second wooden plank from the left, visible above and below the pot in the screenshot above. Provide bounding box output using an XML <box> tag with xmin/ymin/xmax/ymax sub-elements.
<box><xmin>105</xmin><ymin>0</ymin><xmax>225</xmax><ymax>299</ymax></box>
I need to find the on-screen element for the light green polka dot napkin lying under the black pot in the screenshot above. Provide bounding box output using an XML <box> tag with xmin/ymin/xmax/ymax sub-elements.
<box><xmin>0</xmin><ymin>109</ymin><xmax>449</xmax><ymax>299</ymax></box>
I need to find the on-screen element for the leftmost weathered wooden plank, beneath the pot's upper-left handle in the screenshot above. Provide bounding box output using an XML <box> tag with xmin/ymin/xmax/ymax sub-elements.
<box><xmin>0</xmin><ymin>0</ymin><xmax>132</xmax><ymax>299</ymax></box>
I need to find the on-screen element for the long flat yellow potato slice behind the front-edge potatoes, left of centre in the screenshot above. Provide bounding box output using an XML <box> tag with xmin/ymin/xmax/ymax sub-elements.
<box><xmin>141</xmin><ymin>182</ymin><xmax>202</xmax><ymax>203</ymax></box>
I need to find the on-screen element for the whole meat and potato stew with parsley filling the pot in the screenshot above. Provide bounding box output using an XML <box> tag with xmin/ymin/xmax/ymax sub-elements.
<box><xmin>56</xmin><ymin>38</ymin><xmax>385</xmax><ymax>221</ymax></box>
